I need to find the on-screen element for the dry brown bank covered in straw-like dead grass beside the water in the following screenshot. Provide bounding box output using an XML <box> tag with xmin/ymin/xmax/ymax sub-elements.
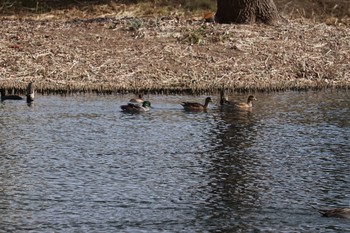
<box><xmin>0</xmin><ymin>4</ymin><xmax>350</xmax><ymax>93</ymax></box>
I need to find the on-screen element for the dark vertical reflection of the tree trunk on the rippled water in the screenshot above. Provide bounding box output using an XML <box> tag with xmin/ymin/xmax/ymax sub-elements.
<box><xmin>201</xmin><ymin>98</ymin><xmax>266</xmax><ymax>226</ymax></box>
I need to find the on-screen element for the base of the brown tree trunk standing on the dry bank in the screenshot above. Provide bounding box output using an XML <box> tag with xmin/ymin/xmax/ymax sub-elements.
<box><xmin>215</xmin><ymin>0</ymin><xmax>284</xmax><ymax>25</ymax></box>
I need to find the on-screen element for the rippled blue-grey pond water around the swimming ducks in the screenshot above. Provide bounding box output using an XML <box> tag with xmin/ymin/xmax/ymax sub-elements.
<box><xmin>0</xmin><ymin>91</ymin><xmax>350</xmax><ymax>232</ymax></box>
